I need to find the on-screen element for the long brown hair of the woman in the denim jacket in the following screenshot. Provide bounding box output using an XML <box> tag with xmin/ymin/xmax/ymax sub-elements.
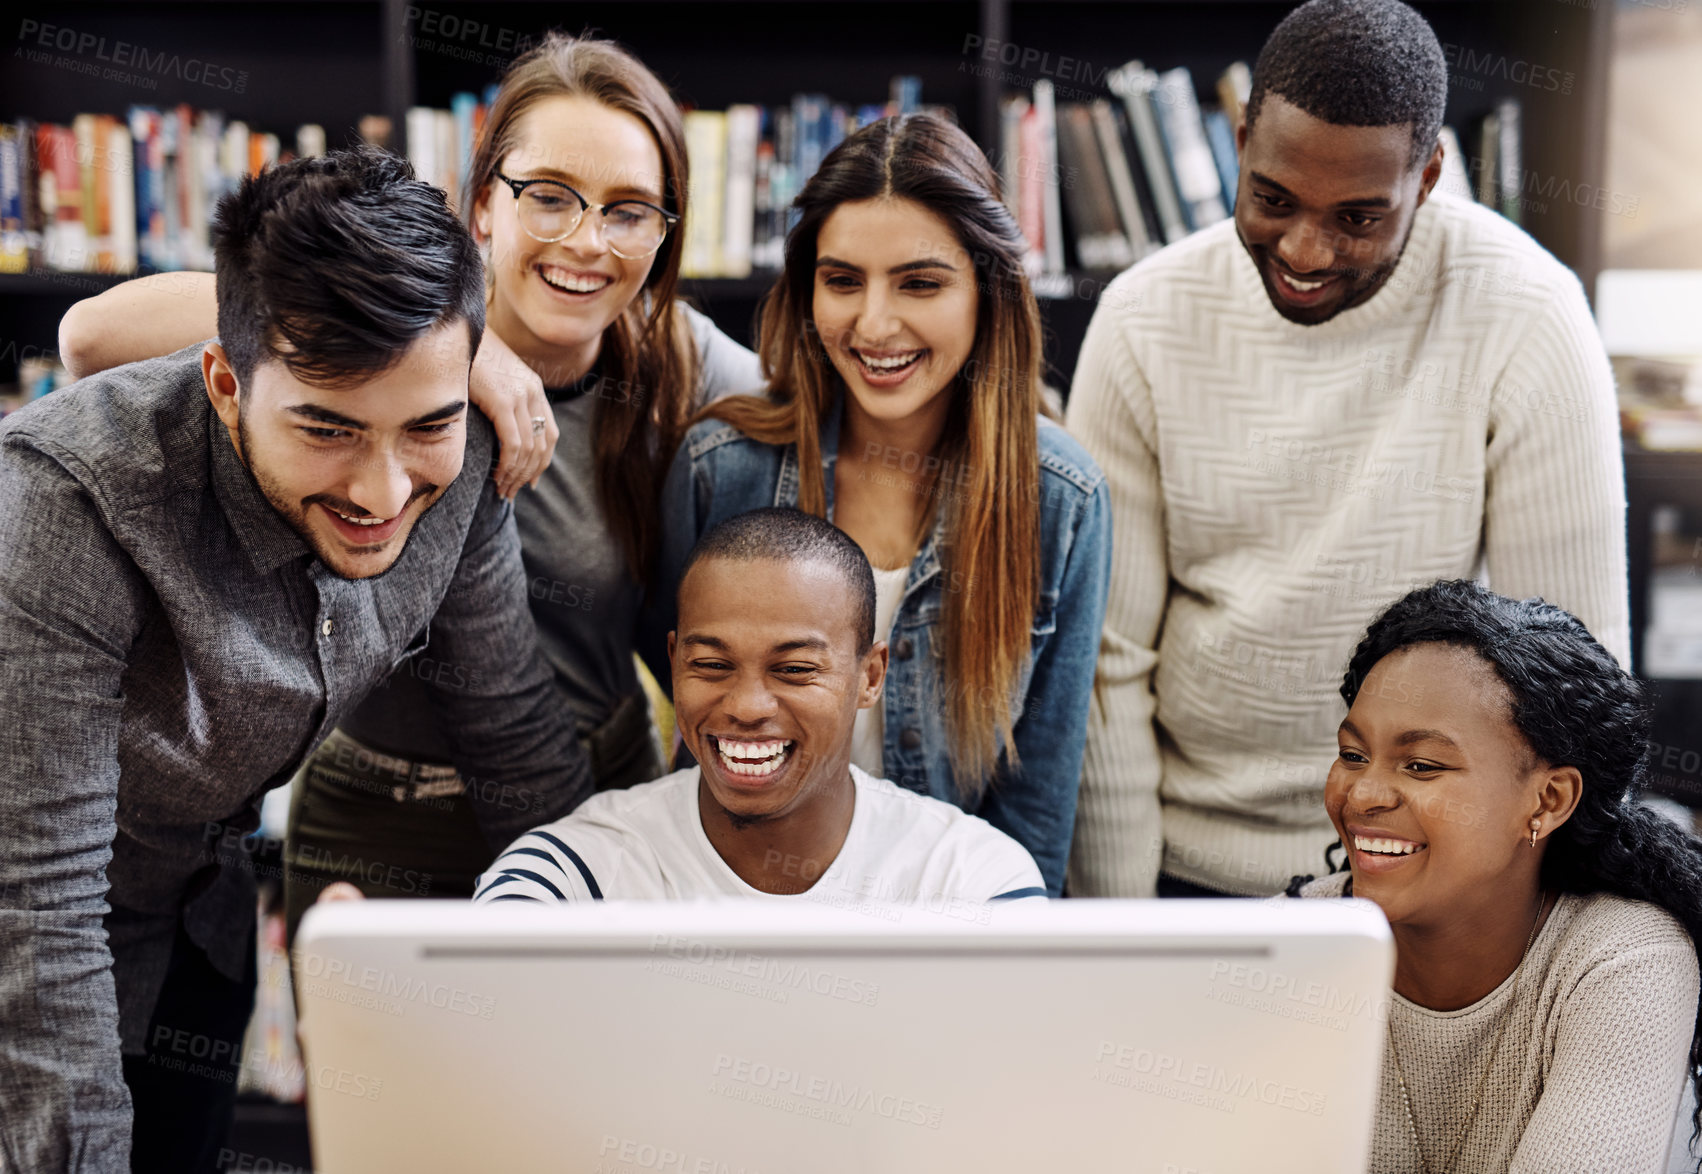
<box><xmin>701</xmin><ymin>114</ymin><xmax>1045</xmax><ymax>798</ymax></box>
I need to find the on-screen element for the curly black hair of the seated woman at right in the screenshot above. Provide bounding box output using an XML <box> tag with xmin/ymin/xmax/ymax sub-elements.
<box><xmin>1341</xmin><ymin>580</ymin><xmax>1702</xmax><ymax>1142</ymax></box>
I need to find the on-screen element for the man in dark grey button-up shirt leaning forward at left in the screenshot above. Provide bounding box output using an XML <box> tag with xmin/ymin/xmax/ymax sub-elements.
<box><xmin>0</xmin><ymin>150</ymin><xmax>591</xmax><ymax>1174</ymax></box>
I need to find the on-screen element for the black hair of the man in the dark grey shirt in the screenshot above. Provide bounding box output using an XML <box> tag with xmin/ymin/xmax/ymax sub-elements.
<box><xmin>213</xmin><ymin>146</ymin><xmax>485</xmax><ymax>388</ymax></box>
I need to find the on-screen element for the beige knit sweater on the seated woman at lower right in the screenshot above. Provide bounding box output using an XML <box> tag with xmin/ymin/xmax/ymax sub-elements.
<box><xmin>1300</xmin><ymin>873</ymin><xmax>1697</xmax><ymax>1174</ymax></box>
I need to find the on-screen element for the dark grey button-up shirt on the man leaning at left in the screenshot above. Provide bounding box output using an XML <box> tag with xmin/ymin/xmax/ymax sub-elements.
<box><xmin>0</xmin><ymin>345</ymin><xmax>591</xmax><ymax>1172</ymax></box>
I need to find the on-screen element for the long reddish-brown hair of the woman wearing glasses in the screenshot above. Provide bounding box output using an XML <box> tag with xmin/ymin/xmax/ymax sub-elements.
<box><xmin>461</xmin><ymin>32</ymin><xmax>698</xmax><ymax>582</ymax></box>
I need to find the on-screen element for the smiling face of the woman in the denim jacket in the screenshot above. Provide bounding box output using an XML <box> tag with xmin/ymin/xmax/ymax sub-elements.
<box><xmin>812</xmin><ymin>197</ymin><xmax>979</xmax><ymax>429</ymax></box>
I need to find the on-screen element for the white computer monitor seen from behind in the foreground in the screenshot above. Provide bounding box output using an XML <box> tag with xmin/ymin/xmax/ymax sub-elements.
<box><xmin>296</xmin><ymin>900</ymin><xmax>1394</xmax><ymax>1174</ymax></box>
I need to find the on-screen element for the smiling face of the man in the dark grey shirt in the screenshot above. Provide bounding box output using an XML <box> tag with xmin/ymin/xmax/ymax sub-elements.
<box><xmin>203</xmin><ymin>322</ymin><xmax>471</xmax><ymax>578</ymax></box>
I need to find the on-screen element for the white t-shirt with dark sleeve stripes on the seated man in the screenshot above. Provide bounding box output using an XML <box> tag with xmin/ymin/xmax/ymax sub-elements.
<box><xmin>473</xmin><ymin>766</ymin><xmax>1047</xmax><ymax>912</ymax></box>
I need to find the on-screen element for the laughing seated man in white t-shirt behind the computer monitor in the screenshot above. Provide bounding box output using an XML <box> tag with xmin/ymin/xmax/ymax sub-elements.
<box><xmin>475</xmin><ymin>509</ymin><xmax>1047</xmax><ymax>912</ymax></box>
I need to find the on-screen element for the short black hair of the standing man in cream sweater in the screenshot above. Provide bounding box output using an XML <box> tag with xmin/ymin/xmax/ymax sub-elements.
<box><xmin>1246</xmin><ymin>0</ymin><xmax>1448</xmax><ymax>167</ymax></box>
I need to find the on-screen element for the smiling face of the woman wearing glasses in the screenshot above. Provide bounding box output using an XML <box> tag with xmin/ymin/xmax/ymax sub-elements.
<box><xmin>473</xmin><ymin>95</ymin><xmax>664</xmax><ymax>385</ymax></box>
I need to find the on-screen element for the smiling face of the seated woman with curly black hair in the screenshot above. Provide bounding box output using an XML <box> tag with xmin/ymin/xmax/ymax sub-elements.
<box><xmin>1324</xmin><ymin>645</ymin><xmax>1578</xmax><ymax>927</ymax></box>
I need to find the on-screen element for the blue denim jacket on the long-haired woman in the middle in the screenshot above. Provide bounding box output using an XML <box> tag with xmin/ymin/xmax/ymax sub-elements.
<box><xmin>652</xmin><ymin>393</ymin><xmax>1111</xmax><ymax>897</ymax></box>
